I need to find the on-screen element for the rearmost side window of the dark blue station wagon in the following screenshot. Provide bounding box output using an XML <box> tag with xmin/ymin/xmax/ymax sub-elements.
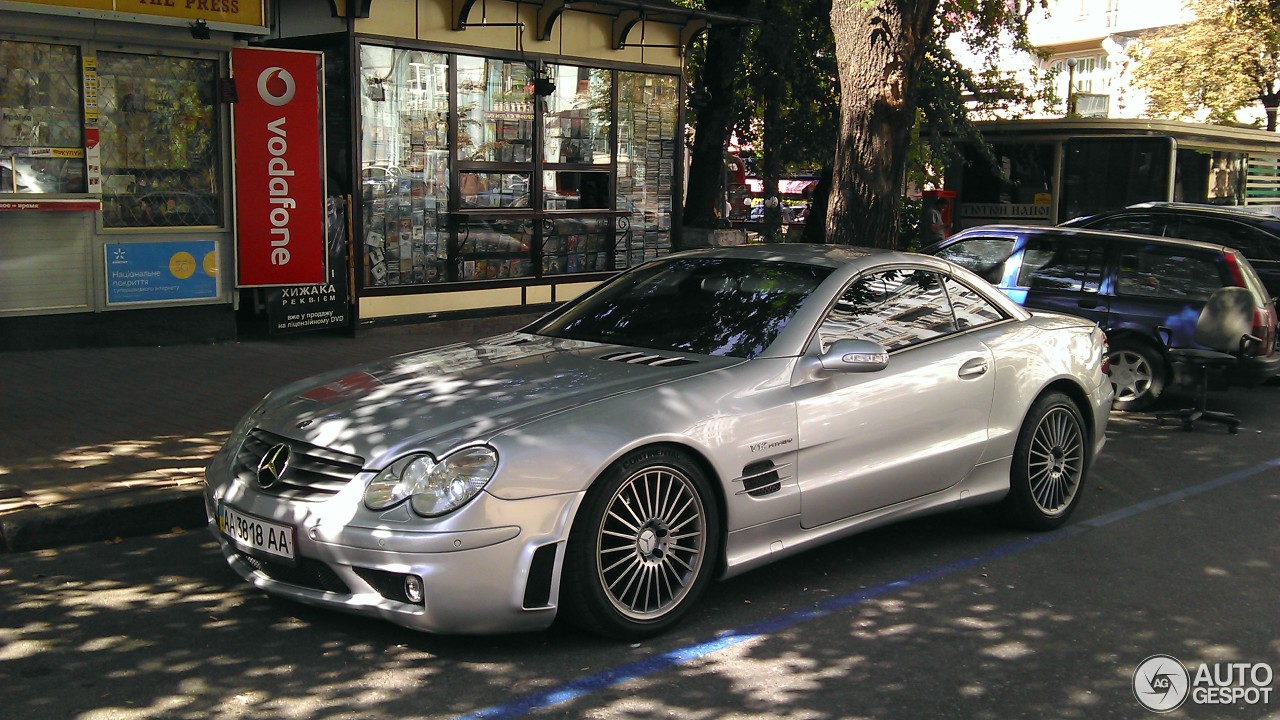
<box><xmin>1116</xmin><ymin>245</ymin><xmax>1225</xmax><ymax>301</ymax></box>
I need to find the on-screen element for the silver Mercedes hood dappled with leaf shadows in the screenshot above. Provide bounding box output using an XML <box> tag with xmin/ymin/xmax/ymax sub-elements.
<box><xmin>255</xmin><ymin>333</ymin><xmax>742</xmax><ymax>469</ymax></box>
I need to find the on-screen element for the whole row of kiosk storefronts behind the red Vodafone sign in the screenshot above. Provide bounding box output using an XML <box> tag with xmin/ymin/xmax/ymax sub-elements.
<box><xmin>0</xmin><ymin>0</ymin><xmax>742</xmax><ymax>348</ymax></box>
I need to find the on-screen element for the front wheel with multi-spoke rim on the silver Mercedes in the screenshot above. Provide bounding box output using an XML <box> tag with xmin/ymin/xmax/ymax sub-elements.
<box><xmin>561</xmin><ymin>447</ymin><xmax>721</xmax><ymax>639</ymax></box>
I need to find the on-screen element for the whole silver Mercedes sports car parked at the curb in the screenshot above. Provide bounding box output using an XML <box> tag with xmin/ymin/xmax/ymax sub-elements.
<box><xmin>206</xmin><ymin>245</ymin><xmax>1112</xmax><ymax>638</ymax></box>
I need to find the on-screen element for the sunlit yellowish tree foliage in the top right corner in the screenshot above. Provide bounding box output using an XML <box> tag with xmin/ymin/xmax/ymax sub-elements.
<box><xmin>1130</xmin><ymin>0</ymin><xmax>1280</xmax><ymax>131</ymax></box>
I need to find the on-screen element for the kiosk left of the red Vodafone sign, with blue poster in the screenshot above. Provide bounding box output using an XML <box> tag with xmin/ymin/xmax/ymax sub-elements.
<box><xmin>0</xmin><ymin>0</ymin><xmax>268</xmax><ymax>348</ymax></box>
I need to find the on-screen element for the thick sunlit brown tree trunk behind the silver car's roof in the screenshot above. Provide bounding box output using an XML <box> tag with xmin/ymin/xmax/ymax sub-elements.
<box><xmin>827</xmin><ymin>0</ymin><xmax>938</xmax><ymax>247</ymax></box>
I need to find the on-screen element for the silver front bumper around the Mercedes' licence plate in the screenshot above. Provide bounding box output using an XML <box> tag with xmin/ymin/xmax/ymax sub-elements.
<box><xmin>205</xmin><ymin>466</ymin><xmax>581</xmax><ymax>633</ymax></box>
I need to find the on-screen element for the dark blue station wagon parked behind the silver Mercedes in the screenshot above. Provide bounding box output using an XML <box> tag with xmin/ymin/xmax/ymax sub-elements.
<box><xmin>924</xmin><ymin>225</ymin><xmax>1280</xmax><ymax>410</ymax></box>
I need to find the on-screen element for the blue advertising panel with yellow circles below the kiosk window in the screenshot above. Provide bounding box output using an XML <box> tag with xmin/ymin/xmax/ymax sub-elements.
<box><xmin>106</xmin><ymin>240</ymin><xmax>218</xmax><ymax>305</ymax></box>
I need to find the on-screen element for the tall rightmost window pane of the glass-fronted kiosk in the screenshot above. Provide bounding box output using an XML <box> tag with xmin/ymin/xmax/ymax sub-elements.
<box><xmin>617</xmin><ymin>72</ymin><xmax>680</xmax><ymax>269</ymax></box>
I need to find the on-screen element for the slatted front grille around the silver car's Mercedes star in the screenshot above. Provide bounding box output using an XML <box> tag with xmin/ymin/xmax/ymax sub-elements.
<box><xmin>236</xmin><ymin>429</ymin><xmax>365</xmax><ymax>501</ymax></box>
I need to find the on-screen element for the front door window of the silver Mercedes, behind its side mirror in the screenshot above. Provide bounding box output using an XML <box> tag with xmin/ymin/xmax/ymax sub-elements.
<box><xmin>818</xmin><ymin>270</ymin><xmax>956</xmax><ymax>351</ymax></box>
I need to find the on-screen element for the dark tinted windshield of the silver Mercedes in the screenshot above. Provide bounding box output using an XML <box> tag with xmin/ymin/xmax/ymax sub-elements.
<box><xmin>529</xmin><ymin>258</ymin><xmax>831</xmax><ymax>359</ymax></box>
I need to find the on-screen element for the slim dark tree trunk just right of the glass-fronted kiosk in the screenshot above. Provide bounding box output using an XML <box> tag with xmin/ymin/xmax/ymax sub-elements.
<box><xmin>684</xmin><ymin>7</ymin><xmax>745</xmax><ymax>228</ymax></box>
